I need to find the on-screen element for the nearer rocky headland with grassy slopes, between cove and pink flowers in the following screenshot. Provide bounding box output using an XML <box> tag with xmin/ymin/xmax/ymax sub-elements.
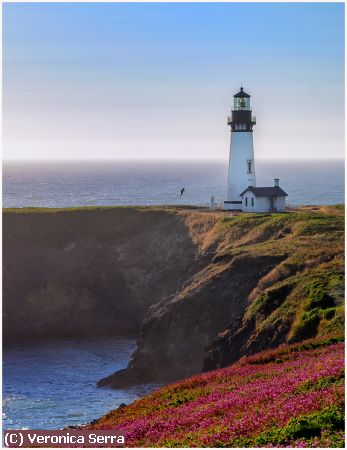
<box><xmin>99</xmin><ymin>208</ymin><xmax>344</xmax><ymax>387</ymax></box>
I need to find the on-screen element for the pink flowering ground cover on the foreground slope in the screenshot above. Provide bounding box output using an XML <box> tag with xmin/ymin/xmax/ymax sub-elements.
<box><xmin>88</xmin><ymin>337</ymin><xmax>344</xmax><ymax>447</ymax></box>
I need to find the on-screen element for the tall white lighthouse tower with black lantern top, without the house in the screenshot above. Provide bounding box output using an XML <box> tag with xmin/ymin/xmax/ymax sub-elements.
<box><xmin>224</xmin><ymin>86</ymin><xmax>256</xmax><ymax>211</ymax></box>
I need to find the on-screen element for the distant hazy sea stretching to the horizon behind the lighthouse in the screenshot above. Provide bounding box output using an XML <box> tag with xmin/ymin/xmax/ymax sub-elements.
<box><xmin>3</xmin><ymin>160</ymin><xmax>344</xmax><ymax>207</ymax></box>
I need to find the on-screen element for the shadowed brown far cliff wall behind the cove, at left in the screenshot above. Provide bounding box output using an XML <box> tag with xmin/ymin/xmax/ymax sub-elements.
<box><xmin>3</xmin><ymin>208</ymin><xmax>219</xmax><ymax>340</ymax></box>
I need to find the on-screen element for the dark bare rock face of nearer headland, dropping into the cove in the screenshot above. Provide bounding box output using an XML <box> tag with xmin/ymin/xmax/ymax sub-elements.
<box><xmin>99</xmin><ymin>255</ymin><xmax>284</xmax><ymax>387</ymax></box>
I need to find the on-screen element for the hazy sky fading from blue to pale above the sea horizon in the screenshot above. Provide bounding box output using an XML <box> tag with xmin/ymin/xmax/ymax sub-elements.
<box><xmin>3</xmin><ymin>3</ymin><xmax>344</xmax><ymax>159</ymax></box>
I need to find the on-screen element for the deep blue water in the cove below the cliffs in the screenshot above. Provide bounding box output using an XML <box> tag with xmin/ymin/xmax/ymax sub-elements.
<box><xmin>3</xmin><ymin>337</ymin><xmax>155</xmax><ymax>429</ymax></box>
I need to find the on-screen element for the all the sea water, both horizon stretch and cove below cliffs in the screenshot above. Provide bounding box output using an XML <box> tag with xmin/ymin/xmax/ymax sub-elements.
<box><xmin>3</xmin><ymin>157</ymin><xmax>344</xmax><ymax>429</ymax></box>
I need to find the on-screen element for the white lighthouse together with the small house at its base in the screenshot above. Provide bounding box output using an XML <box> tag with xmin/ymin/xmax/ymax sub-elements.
<box><xmin>224</xmin><ymin>86</ymin><xmax>287</xmax><ymax>212</ymax></box>
